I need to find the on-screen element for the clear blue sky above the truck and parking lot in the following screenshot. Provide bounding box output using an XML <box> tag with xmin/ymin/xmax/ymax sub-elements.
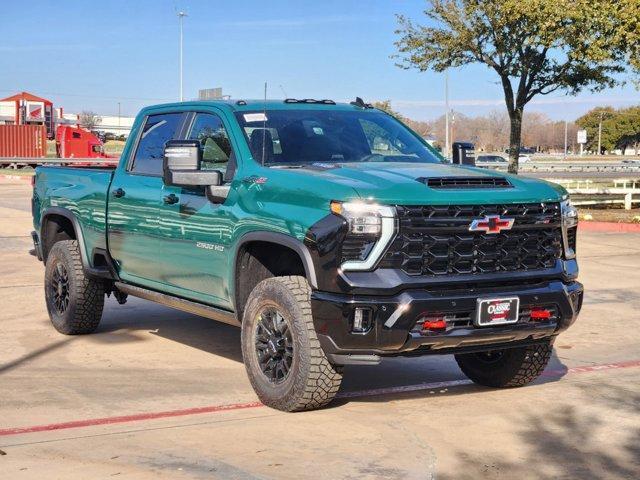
<box><xmin>0</xmin><ymin>0</ymin><xmax>640</xmax><ymax>119</ymax></box>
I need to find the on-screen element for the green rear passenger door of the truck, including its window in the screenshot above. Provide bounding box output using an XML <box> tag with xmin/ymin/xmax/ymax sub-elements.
<box><xmin>107</xmin><ymin>113</ymin><xmax>185</xmax><ymax>288</ymax></box>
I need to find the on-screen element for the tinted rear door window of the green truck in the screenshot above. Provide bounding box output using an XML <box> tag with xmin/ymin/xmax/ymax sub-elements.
<box><xmin>131</xmin><ymin>113</ymin><xmax>182</xmax><ymax>175</ymax></box>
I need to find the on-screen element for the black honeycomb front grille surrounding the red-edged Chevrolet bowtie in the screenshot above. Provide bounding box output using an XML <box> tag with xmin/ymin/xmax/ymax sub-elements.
<box><xmin>379</xmin><ymin>203</ymin><xmax>562</xmax><ymax>275</ymax></box>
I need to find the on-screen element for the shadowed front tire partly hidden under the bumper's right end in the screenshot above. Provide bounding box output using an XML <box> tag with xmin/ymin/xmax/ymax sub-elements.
<box><xmin>455</xmin><ymin>343</ymin><xmax>552</xmax><ymax>388</ymax></box>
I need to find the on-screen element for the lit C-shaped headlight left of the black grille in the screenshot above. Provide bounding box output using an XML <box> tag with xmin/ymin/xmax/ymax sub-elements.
<box><xmin>331</xmin><ymin>202</ymin><xmax>395</xmax><ymax>270</ymax></box>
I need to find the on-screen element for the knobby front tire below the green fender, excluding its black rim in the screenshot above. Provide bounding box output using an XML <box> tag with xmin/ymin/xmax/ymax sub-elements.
<box><xmin>242</xmin><ymin>276</ymin><xmax>342</xmax><ymax>412</ymax></box>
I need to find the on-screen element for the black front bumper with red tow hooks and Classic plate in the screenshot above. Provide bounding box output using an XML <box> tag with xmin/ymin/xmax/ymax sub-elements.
<box><xmin>311</xmin><ymin>280</ymin><xmax>583</xmax><ymax>364</ymax></box>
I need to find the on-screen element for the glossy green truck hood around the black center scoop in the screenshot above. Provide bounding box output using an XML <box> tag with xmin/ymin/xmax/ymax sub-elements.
<box><xmin>298</xmin><ymin>162</ymin><xmax>566</xmax><ymax>205</ymax></box>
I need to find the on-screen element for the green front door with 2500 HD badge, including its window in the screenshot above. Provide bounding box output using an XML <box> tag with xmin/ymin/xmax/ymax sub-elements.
<box><xmin>159</xmin><ymin>113</ymin><xmax>237</xmax><ymax>308</ymax></box>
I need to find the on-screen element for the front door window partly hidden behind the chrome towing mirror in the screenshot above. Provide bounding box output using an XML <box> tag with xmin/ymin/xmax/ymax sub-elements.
<box><xmin>188</xmin><ymin>113</ymin><xmax>234</xmax><ymax>170</ymax></box>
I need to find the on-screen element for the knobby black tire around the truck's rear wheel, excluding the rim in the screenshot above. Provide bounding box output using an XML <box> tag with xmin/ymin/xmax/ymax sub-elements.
<box><xmin>44</xmin><ymin>240</ymin><xmax>104</xmax><ymax>335</ymax></box>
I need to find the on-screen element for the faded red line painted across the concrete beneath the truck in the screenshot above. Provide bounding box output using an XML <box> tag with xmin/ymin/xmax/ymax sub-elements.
<box><xmin>0</xmin><ymin>360</ymin><xmax>640</xmax><ymax>437</ymax></box>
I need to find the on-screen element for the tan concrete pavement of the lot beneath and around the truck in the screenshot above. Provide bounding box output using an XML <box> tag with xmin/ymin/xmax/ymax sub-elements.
<box><xmin>0</xmin><ymin>181</ymin><xmax>640</xmax><ymax>479</ymax></box>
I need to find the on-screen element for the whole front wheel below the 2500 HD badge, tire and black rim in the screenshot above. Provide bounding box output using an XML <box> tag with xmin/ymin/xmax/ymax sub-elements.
<box><xmin>242</xmin><ymin>277</ymin><xmax>342</xmax><ymax>412</ymax></box>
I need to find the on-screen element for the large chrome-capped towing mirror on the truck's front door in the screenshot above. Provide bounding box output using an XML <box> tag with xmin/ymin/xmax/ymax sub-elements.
<box><xmin>162</xmin><ymin>140</ymin><xmax>222</xmax><ymax>187</ymax></box>
